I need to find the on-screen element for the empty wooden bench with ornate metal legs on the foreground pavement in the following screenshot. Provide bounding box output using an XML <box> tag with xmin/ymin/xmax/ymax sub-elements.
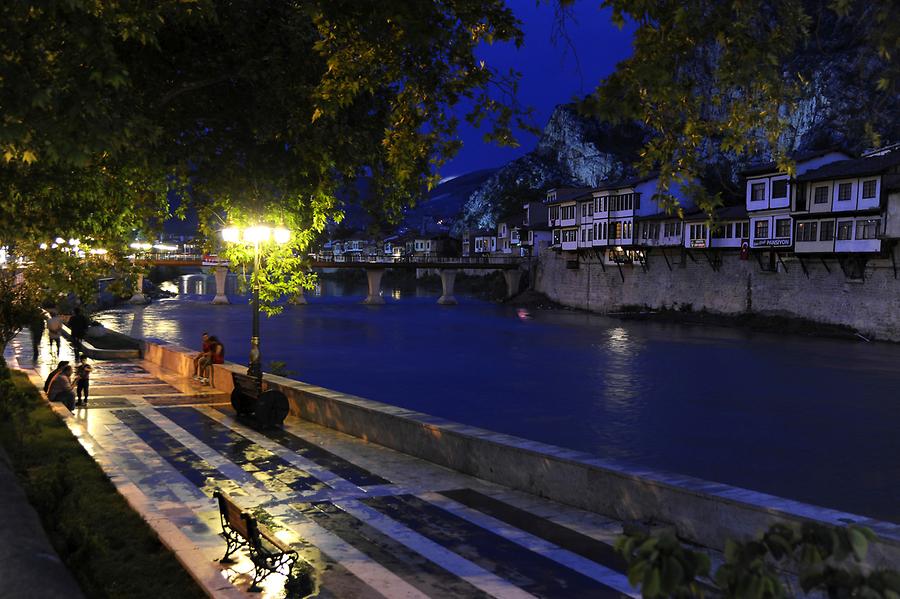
<box><xmin>213</xmin><ymin>490</ymin><xmax>297</xmax><ymax>593</ymax></box>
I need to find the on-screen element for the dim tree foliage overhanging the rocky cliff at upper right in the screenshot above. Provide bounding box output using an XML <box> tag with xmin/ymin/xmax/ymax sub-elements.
<box><xmin>576</xmin><ymin>0</ymin><xmax>900</xmax><ymax>211</ymax></box>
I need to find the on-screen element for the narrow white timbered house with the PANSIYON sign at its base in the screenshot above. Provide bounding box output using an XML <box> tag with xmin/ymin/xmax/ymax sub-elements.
<box><xmin>742</xmin><ymin>150</ymin><xmax>850</xmax><ymax>251</ymax></box>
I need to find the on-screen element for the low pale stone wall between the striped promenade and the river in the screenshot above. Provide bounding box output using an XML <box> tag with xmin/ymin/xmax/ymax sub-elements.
<box><xmin>142</xmin><ymin>341</ymin><xmax>900</xmax><ymax>567</ymax></box>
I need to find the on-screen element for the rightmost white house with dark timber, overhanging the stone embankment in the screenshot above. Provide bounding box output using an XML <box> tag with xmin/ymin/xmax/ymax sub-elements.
<box><xmin>792</xmin><ymin>150</ymin><xmax>900</xmax><ymax>254</ymax></box>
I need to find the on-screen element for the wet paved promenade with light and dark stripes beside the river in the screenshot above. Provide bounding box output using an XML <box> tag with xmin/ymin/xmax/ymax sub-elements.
<box><xmin>7</xmin><ymin>334</ymin><xmax>637</xmax><ymax>598</ymax></box>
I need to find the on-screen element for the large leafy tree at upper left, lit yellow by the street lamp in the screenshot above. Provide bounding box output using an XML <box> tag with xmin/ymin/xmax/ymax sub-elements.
<box><xmin>0</xmin><ymin>0</ymin><xmax>523</xmax><ymax>314</ymax></box>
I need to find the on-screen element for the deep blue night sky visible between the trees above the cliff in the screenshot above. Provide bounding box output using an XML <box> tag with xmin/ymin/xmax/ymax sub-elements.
<box><xmin>441</xmin><ymin>0</ymin><xmax>632</xmax><ymax>177</ymax></box>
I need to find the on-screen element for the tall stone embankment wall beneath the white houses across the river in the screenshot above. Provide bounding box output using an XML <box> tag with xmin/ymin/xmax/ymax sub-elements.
<box><xmin>535</xmin><ymin>248</ymin><xmax>900</xmax><ymax>341</ymax></box>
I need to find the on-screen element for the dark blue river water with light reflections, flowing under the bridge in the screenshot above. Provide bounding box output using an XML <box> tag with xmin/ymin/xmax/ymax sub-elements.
<box><xmin>98</xmin><ymin>275</ymin><xmax>900</xmax><ymax>522</ymax></box>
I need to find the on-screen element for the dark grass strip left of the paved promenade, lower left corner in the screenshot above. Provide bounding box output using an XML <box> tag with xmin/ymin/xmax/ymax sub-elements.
<box><xmin>0</xmin><ymin>366</ymin><xmax>205</xmax><ymax>599</ymax></box>
